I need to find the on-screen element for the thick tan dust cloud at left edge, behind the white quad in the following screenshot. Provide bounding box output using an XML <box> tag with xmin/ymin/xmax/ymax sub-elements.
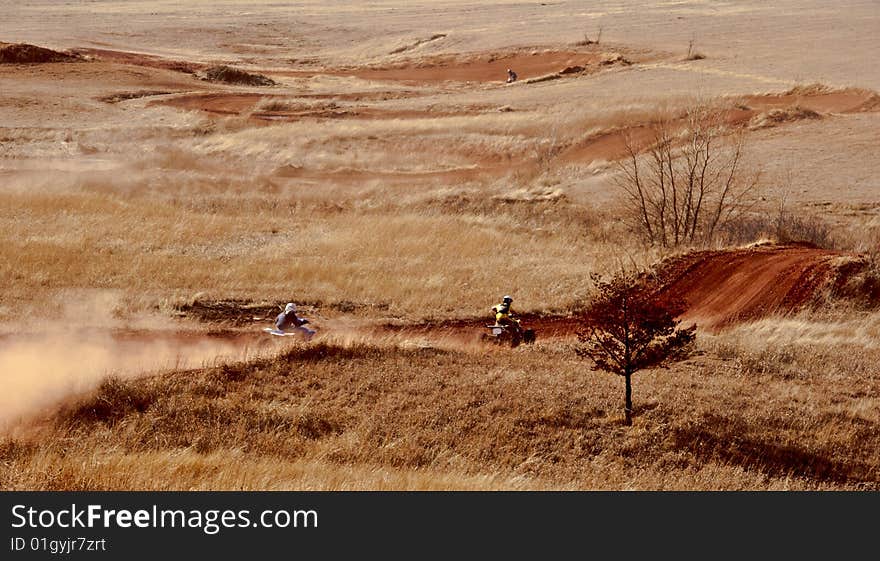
<box><xmin>0</xmin><ymin>291</ymin><xmax>259</xmax><ymax>431</ymax></box>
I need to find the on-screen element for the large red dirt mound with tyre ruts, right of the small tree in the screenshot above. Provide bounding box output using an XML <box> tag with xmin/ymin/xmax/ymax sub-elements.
<box><xmin>657</xmin><ymin>245</ymin><xmax>880</xmax><ymax>328</ymax></box>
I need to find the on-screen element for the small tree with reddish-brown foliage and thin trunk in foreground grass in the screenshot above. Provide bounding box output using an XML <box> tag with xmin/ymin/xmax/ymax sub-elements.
<box><xmin>578</xmin><ymin>274</ymin><xmax>697</xmax><ymax>426</ymax></box>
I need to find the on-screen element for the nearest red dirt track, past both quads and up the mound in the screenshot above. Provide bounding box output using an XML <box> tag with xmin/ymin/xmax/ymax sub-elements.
<box><xmin>179</xmin><ymin>244</ymin><xmax>880</xmax><ymax>344</ymax></box>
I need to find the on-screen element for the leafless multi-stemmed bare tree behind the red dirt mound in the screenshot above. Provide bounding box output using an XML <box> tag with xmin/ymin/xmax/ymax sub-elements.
<box><xmin>617</xmin><ymin>106</ymin><xmax>758</xmax><ymax>247</ymax></box>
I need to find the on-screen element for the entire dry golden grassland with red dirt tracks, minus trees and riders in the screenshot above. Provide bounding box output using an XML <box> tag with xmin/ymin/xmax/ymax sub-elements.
<box><xmin>0</xmin><ymin>0</ymin><xmax>880</xmax><ymax>490</ymax></box>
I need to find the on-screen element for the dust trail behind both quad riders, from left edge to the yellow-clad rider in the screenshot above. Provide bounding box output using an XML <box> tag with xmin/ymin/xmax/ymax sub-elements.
<box><xmin>0</xmin><ymin>306</ymin><xmax>474</xmax><ymax>428</ymax></box>
